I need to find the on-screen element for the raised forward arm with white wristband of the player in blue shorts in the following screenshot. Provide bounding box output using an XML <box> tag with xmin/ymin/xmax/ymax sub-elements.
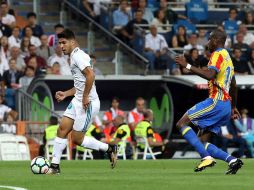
<box><xmin>176</xmin><ymin>56</ymin><xmax>216</xmax><ymax>80</ymax></box>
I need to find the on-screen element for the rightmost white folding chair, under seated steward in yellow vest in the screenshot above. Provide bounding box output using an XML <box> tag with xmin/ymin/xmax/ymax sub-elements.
<box><xmin>134</xmin><ymin>136</ymin><xmax>162</xmax><ymax>160</ymax></box>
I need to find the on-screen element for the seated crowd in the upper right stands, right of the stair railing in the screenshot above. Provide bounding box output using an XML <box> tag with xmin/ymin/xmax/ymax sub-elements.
<box><xmin>83</xmin><ymin>0</ymin><xmax>254</xmax><ymax>75</ymax></box>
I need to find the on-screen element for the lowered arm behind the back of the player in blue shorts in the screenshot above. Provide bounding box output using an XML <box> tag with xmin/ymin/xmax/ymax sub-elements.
<box><xmin>229</xmin><ymin>76</ymin><xmax>241</xmax><ymax>119</ymax></box>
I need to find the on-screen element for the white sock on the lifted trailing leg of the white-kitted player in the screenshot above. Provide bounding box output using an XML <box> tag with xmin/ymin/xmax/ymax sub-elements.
<box><xmin>81</xmin><ymin>136</ymin><xmax>108</xmax><ymax>152</ymax></box>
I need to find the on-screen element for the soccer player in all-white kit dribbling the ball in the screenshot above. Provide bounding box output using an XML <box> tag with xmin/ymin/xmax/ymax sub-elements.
<box><xmin>47</xmin><ymin>29</ymin><xmax>117</xmax><ymax>174</ymax></box>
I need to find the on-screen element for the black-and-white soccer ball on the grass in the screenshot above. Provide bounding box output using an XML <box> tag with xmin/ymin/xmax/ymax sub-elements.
<box><xmin>31</xmin><ymin>156</ymin><xmax>49</xmax><ymax>174</ymax></box>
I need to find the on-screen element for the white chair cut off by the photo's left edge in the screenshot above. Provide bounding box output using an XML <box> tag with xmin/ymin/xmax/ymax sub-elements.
<box><xmin>0</xmin><ymin>134</ymin><xmax>21</xmax><ymax>160</ymax></box>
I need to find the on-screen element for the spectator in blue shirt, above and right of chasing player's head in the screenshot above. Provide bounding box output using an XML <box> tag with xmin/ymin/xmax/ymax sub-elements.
<box><xmin>222</xmin><ymin>8</ymin><xmax>241</xmax><ymax>39</ymax></box>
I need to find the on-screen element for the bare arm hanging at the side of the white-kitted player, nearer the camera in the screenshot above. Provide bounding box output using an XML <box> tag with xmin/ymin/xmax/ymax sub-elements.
<box><xmin>82</xmin><ymin>67</ymin><xmax>95</xmax><ymax>109</ymax></box>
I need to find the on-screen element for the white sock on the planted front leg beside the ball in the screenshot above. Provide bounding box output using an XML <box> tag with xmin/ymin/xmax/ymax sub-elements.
<box><xmin>51</xmin><ymin>137</ymin><xmax>67</xmax><ymax>164</ymax></box>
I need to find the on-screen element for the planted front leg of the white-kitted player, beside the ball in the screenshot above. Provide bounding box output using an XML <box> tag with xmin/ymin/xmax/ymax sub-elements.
<box><xmin>47</xmin><ymin>116</ymin><xmax>74</xmax><ymax>174</ymax></box>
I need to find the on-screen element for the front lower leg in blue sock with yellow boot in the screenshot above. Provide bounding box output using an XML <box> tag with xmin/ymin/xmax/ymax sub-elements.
<box><xmin>176</xmin><ymin>114</ymin><xmax>216</xmax><ymax>172</ymax></box>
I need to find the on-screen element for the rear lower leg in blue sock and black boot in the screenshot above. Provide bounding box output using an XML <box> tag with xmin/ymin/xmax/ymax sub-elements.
<box><xmin>205</xmin><ymin>143</ymin><xmax>243</xmax><ymax>174</ymax></box>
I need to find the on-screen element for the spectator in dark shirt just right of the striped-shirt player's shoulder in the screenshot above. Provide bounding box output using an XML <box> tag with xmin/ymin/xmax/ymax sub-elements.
<box><xmin>232</xmin><ymin>48</ymin><xmax>249</xmax><ymax>75</ymax></box>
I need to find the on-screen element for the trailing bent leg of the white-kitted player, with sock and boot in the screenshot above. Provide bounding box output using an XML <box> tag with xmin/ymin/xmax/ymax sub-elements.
<box><xmin>72</xmin><ymin>130</ymin><xmax>117</xmax><ymax>169</ymax></box>
